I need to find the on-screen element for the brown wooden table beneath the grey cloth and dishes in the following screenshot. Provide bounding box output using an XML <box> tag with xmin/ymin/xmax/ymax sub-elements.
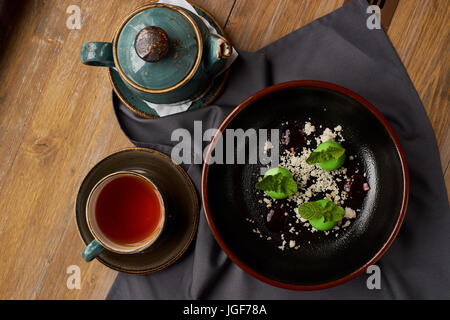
<box><xmin>0</xmin><ymin>0</ymin><xmax>450</xmax><ymax>299</ymax></box>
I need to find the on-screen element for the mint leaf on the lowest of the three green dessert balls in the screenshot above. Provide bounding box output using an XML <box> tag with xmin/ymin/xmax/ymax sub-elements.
<box><xmin>298</xmin><ymin>200</ymin><xmax>345</xmax><ymax>222</ymax></box>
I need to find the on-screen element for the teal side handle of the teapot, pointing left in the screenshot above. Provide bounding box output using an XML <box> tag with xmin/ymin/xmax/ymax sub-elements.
<box><xmin>81</xmin><ymin>42</ymin><xmax>114</xmax><ymax>67</ymax></box>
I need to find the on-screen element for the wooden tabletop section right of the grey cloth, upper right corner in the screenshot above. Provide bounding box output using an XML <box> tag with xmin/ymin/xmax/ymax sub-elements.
<box><xmin>388</xmin><ymin>0</ymin><xmax>450</xmax><ymax>172</ymax></box>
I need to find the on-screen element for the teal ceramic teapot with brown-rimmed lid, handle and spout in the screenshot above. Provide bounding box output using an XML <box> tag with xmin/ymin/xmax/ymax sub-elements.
<box><xmin>81</xmin><ymin>3</ymin><xmax>233</xmax><ymax>105</ymax></box>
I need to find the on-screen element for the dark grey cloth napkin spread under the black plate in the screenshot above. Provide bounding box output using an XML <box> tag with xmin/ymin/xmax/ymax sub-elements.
<box><xmin>107</xmin><ymin>0</ymin><xmax>450</xmax><ymax>299</ymax></box>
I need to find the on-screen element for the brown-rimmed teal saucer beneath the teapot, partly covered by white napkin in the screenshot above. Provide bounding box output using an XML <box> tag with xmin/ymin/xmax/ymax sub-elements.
<box><xmin>108</xmin><ymin>4</ymin><xmax>229</xmax><ymax>118</ymax></box>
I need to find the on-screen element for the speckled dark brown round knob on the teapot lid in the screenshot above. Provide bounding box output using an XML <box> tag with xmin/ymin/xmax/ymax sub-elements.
<box><xmin>134</xmin><ymin>26</ymin><xmax>169</xmax><ymax>62</ymax></box>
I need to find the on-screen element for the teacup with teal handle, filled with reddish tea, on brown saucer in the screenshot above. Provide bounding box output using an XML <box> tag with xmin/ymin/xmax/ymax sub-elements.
<box><xmin>81</xmin><ymin>171</ymin><xmax>166</xmax><ymax>262</ymax></box>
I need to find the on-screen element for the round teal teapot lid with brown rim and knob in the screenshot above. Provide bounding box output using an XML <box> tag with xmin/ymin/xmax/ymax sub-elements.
<box><xmin>113</xmin><ymin>3</ymin><xmax>203</xmax><ymax>93</ymax></box>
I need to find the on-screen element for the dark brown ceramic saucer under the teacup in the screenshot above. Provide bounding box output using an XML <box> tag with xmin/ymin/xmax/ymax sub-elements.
<box><xmin>75</xmin><ymin>148</ymin><xmax>199</xmax><ymax>274</ymax></box>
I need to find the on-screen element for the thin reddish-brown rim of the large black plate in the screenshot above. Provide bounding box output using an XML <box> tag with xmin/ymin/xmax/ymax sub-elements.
<box><xmin>201</xmin><ymin>80</ymin><xmax>409</xmax><ymax>290</ymax></box>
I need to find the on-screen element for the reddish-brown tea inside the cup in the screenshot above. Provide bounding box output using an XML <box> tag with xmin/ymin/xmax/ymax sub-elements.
<box><xmin>95</xmin><ymin>175</ymin><xmax>163</xmax><ymax>245</ymax></box>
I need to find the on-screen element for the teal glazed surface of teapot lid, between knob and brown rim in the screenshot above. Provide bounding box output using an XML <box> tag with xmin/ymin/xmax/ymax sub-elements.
<box><xmin>117</xmin><ymin>8</ymin><xmax>198</xmax><ymax>90</ymax></box>
